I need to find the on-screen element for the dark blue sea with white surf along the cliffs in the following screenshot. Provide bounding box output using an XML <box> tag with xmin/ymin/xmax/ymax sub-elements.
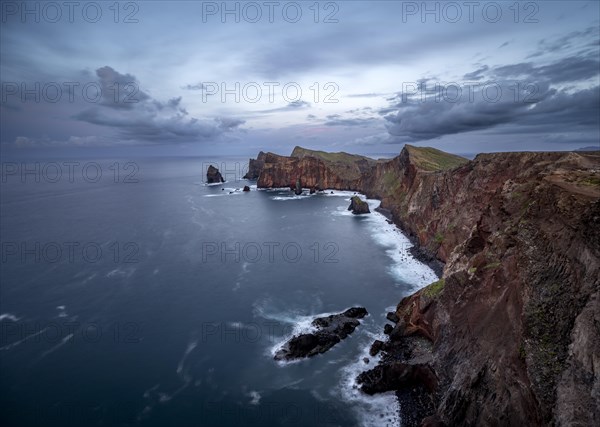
<box><xmin>0</xmin><ymin>158</ymin><xmax>435</xmax><ymax>427</ymax></box>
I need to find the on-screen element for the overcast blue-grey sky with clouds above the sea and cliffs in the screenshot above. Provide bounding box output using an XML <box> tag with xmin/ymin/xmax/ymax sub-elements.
<box><xmin>0</xmin><ymin>1</ymin><xmax>600</xmax><ymax>156</ymax></box>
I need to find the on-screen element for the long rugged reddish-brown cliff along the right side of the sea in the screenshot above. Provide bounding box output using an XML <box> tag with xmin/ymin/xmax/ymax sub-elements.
<box><xmin>248</xmin><ymin>146</ymin><xmax>600</xmax><ymax>425</ymax></box>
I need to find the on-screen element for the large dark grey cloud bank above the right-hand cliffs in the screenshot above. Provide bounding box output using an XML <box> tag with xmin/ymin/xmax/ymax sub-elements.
<box><xmin>379</xmin><ymin>53</ymin><xmax>600</xmax><ymax>141</ymax></box>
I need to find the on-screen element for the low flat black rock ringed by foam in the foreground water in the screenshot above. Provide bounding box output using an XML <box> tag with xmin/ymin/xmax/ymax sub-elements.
<box><xmin>274</xmin><ymin>307</ymin><xmax>367</xmax><ymax>361</ymax></box>
